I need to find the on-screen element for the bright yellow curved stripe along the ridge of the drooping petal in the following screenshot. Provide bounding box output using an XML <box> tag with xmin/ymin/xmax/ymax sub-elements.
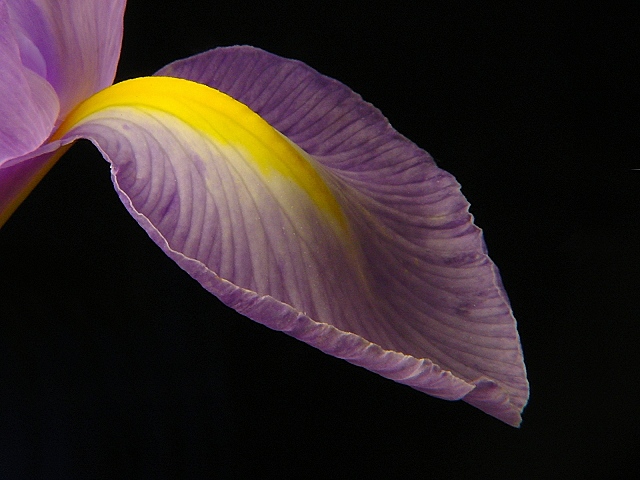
<box><xmin>53</xmin><ymin>77</ymin><xmax>346</xmax><ymax>229</ymax></box>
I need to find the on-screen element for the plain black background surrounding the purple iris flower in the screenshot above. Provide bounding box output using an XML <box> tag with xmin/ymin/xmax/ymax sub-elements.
<box><xmin>0</xmin><ymin>0</ymin><xmax>640</xmax><ymax>478</ymax></box>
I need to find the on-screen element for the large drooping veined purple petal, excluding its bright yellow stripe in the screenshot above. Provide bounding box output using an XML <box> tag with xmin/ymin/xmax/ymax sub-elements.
<box><xmin>65</xmin><ymin>47</ymin><xmax>528</xmax><ymax>425</ymax></box>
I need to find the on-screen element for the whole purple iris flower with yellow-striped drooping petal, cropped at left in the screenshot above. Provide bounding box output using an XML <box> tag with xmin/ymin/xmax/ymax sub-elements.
<box><xmin>0</xmin><ymin>0</ymin><xmax>528</xmax><ymax>426</ymax></box>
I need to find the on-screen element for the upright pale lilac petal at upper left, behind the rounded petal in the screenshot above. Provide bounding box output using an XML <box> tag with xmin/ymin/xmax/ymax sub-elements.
<box><xmin>6</xmin><ymin>0</ymin><xmax>126</xmax><ymax>116</ymax></box>
